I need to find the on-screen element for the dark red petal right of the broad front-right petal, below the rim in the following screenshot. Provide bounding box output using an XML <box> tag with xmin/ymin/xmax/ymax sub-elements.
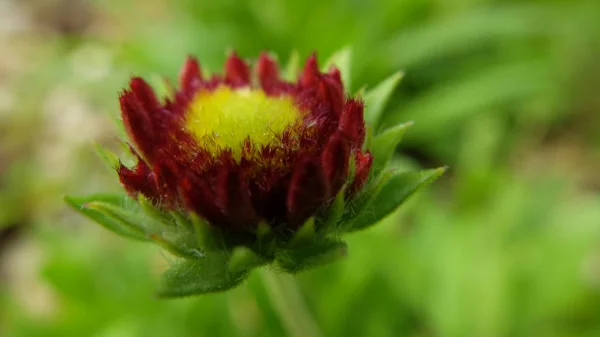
<box><xmin>321</xmin><ymin>134</ymin><xmax>350</xmax><ymax>197</ymax></box>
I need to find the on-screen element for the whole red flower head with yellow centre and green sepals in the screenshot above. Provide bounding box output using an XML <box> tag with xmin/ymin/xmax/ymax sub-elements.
<box><xmin>66</xmin><ymin>48</ymin><xmax>445</xmax><ymax>296</ymax></box>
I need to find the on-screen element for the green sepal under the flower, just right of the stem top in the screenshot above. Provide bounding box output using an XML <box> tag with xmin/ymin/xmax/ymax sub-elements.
<box><xmin>276</xmin><ymin>240</ymin><xmax>347</xmax><ymax>274</ymax></box>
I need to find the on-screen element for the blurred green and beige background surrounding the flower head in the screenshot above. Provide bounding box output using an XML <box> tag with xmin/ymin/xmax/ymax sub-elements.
<box><xmin>0</xmin><ymin>0</ymin><xmax>600</xmax><ymax>337</ymax></box>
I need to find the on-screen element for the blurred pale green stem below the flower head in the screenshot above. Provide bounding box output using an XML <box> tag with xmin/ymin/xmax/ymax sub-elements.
<box><xmin>260</xmin><ymin>269</ymin><xmax>322</xmax><ymax>337</ymax></box>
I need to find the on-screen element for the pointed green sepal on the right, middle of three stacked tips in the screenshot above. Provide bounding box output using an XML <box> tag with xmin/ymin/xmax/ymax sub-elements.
<box><xmin>370</xmin><ymin>122</ymin><xmax>414</xmax><ymax>176</ymax></box>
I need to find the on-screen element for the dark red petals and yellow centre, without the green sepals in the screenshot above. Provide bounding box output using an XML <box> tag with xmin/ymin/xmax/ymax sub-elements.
<box><xmin>118</xmin><ymin>53</ymin><xmax>372</xmax><ymax>232</ymax></box>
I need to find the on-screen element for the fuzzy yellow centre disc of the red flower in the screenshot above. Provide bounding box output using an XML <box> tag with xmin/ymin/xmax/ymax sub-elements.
<box><xmin>185</xmin><ymin>86</ymin><xmax>301</xmax><ymax>158</ymax></box>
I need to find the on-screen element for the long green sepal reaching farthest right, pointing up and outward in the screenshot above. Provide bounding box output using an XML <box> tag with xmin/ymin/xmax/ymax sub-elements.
<box><xmin>350</xmin><ymin>167</ymin><xmax>447</xmax><ymax>231</ymax></box>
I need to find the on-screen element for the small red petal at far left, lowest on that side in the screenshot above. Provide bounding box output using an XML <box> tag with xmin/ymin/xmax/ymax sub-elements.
<box><xmin>117</xmin><ymin>158</ymin><xmax>160</xmax><ymax>201</ymax></box>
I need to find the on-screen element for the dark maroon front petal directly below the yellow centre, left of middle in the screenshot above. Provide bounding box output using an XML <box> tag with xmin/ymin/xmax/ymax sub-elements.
<box><xmin>216</xmin><ymin>169</ymin><xmax>258</xmax><ymax>229</ymax></box>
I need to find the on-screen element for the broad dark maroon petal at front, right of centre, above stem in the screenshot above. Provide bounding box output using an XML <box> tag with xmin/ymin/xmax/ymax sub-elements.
<box><xmin>287</xmin><ymin>158</ymin><xmax>329</xmax><ymax>227</ymax></box>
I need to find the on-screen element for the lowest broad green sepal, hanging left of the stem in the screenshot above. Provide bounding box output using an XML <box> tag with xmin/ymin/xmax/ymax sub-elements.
<box><xmin>158</xmin><ymin>251</ymin><xmax>248</xmax><ymax>297</ymax></box>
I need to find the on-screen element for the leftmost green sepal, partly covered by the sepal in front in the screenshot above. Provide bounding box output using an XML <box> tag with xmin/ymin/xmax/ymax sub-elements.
<box><xmin>64</xmin><ymin>194</ymin><xmax>149</xmax><ymax>241</ymax></box>
